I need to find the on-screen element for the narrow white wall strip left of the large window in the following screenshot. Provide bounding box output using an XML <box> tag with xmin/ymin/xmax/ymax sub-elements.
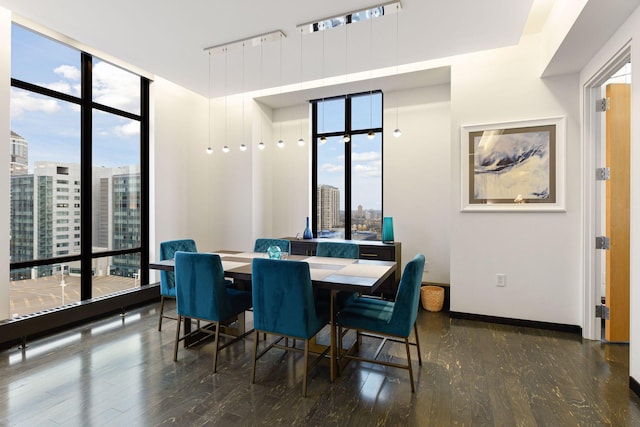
<box><xmin>0</xmin><ymin>7</ymin><xmax>11</xmax><ymax>319</ymax></box>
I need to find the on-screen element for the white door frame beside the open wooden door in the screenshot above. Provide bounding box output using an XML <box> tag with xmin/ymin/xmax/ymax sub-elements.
<box><xmin>582</xmin><ymin>46</ymin><xmax>633</xmax><ymax>340</ymax></box>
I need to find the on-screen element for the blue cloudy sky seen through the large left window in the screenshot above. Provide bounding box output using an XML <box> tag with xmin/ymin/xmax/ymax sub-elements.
<box><xmin>11</xmin><ymin>24</ymin><xmax>140</xmax><ymax>173</ymax></box>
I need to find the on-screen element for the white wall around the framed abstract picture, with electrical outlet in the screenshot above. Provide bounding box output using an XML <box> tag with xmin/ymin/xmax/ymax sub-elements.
<box><xmin>450</xmin><ymin>37</ymin><xmax>582</xmax><ymax>325</ymax></box>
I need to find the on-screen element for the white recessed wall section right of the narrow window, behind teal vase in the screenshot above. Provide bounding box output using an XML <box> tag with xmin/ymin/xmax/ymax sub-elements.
<box><xmin>382</xmin><ymin>85</ymin><xmax>451</xmax><ymax>283</ymax></box>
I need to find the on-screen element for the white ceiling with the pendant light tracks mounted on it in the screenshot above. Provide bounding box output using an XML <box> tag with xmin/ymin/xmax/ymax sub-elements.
<box><xmin>0</xmin><ymin>0</ymin><xmax>536</xmax><ymax>97</ymax></box>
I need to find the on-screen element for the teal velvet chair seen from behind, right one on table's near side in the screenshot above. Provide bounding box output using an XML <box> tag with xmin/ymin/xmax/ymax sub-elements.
<box><xmin>251</xmin><ymin>258</ymin><xmax>330</xmax><ymax>396</ymax></box>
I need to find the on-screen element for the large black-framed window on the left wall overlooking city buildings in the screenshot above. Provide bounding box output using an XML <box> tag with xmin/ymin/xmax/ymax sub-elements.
<box><xmin>9</xmin><ymin>24</ymin><xmax>149</xmax><ymax>316</ymax></box>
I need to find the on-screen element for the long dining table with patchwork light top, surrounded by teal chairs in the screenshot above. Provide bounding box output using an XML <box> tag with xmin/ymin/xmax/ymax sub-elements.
<box><xmin>149</xmin><ymin>250</ymin><xmax>397</xmax><ymax>381</ymax></box>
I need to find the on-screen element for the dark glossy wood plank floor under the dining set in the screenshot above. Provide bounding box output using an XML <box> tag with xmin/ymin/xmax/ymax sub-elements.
<box><xmin>0</xmin><ymin>305</ymin><xmax>640</xmax><ymax>426</ymax></box>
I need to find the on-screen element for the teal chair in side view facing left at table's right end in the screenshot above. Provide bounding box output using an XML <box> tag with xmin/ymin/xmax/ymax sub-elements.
<box><xmin>336</xmin><ymin>254</ymin><xmax>424</xmax><ymax>393</ymax></box>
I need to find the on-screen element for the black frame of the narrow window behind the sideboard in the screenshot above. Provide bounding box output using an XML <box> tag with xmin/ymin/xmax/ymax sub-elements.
<box><xmin>309</xmin><ymin>89</ymin><xmax>384</xmax><ymax>240</ymax></box>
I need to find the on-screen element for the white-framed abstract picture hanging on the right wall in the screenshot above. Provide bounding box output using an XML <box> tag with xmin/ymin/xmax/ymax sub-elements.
<box><xmin>460</xmin><ymin>117</ymin><xmax>566</xmax><ymax>212</ymax></box>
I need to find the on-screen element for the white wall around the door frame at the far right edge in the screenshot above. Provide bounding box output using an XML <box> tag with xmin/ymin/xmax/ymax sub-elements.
<box><xmin>580</xmin><ymin>3</ymin><xmax>640</xmax><ymax>381</ymax></box>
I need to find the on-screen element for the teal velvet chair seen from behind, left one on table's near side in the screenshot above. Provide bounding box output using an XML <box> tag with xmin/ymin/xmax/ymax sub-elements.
<box><xmin>173</xmin><ymin>252</ymin><xmax>251</xmax><ymax>372</ymax></box>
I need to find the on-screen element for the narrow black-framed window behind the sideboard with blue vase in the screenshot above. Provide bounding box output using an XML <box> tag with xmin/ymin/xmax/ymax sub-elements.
<box><xmin>312</xmin><ymin>91</ymin><xmax>382</xmax><ymax>240</ymax></box>
